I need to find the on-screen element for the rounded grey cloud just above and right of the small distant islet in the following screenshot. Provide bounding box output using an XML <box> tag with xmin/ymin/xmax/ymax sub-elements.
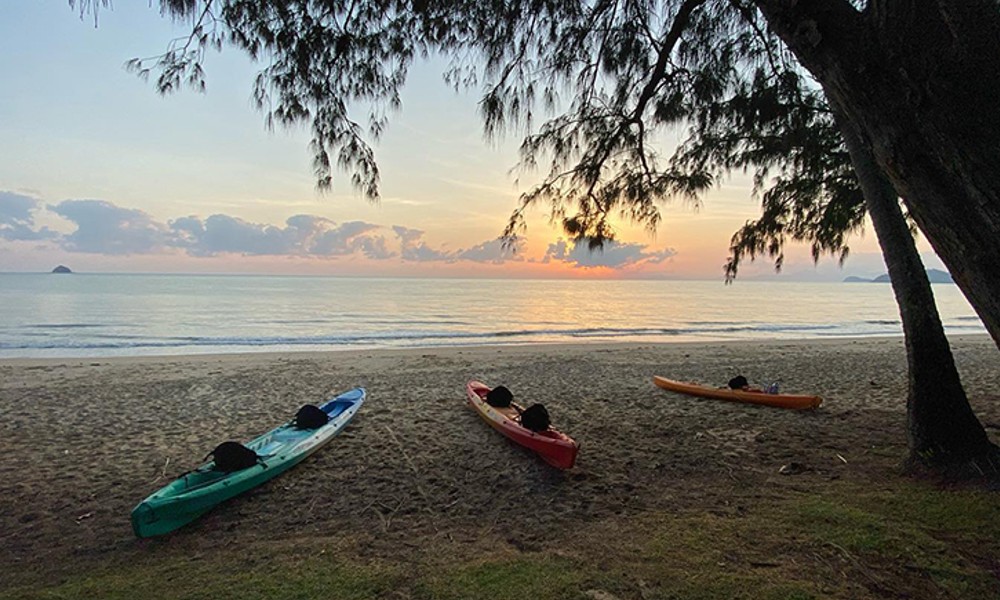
<box><xmin>48</xmin><ymin>200</ymin><xmax>171</xmax><ymax>255</ymax></box>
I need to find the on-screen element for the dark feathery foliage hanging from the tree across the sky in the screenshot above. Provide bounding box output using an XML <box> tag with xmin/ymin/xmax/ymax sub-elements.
<box><xmin>70</xmin><ymin>0</ymin><xmax>864</xmax><ymax>279</ymax></box>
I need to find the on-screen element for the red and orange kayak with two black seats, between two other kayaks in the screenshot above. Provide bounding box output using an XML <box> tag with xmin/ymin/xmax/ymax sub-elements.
<box><xmin>465</xmin><ymin>381</ymin><xmax>580</xmax><ymax>469</ymax></box>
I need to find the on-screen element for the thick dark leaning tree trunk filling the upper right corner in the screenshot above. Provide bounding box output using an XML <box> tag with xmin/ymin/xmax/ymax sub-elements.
<box><xmin>753</xmin><ymin>0</ymin><xmax>1000</xmax><ymax>346</ymax></box>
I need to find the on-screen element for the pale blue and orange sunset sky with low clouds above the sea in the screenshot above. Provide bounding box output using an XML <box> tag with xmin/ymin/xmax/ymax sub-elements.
<box><xmin>0</xmin><ymin>0</ymin><xmax>941</xmax><ymax>281</ymax></box>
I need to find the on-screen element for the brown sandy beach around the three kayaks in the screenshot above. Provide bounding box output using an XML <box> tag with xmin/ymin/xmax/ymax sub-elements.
<box><xmin>0</xmin><ymin>336</ymin><xmax>1000</xmax><ymax>590</ymax></box>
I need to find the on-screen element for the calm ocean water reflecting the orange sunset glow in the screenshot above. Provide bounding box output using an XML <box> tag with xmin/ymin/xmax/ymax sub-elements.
<box><xmin>0</xmin><ymin>273</ymin><xmax>985</xmax><ymax>358</ymax></box>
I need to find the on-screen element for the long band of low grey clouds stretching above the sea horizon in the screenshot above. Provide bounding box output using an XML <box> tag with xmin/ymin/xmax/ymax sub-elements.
<box><xmin>9</xmin><ymin>192</ymin><xmax>675</xmax><ymax>269</ymax></box>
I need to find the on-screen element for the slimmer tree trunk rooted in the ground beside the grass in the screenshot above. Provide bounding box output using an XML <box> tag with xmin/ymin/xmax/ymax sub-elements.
<box><xmin>838</xmin><ymin>115</ymin><xmax>995</xmax><ymax>467</ymax></box>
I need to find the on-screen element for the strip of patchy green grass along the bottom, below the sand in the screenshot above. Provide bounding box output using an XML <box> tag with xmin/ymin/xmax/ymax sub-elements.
<box><xmin>0</xmin><ymin>479</ymin><xmax>1000</xmax><ymax>600</ymax></box>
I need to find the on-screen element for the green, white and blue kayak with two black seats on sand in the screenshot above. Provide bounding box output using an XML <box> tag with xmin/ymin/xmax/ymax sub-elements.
<box><xmin>132</xmin><ymin>388</ymin><xmax>366</xmax><ymax>537</ymax></box>
